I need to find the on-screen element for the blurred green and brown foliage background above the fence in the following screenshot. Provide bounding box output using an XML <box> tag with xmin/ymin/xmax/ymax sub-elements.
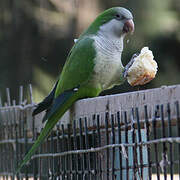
<box><xmin>0</xmin><ymin>0</ymin><xmax>180</xmax><ymax>102</ymax></box>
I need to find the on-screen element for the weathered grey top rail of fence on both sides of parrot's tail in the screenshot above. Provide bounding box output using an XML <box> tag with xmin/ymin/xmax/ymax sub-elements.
<box><xmin>0</xmin><ymin>85</ymin><xmax>180</xmax><ymax>134</ymax></box>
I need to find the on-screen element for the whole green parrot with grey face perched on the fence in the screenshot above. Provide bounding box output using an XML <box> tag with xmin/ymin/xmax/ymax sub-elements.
<box><xmin>16</xmin><ymin>7</ymin><xmax>134</xmax><ymax>173</ymax></box>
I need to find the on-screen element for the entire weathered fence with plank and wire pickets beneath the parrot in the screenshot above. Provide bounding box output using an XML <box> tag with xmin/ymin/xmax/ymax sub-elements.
<box><xmin>0</xmin><ymin>85</ymin><xmax>180</xmax><ymax>180</ymax></box>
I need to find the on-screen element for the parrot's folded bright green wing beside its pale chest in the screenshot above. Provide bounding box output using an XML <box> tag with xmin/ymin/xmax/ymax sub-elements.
<box><xmin>55</xmin><ymin>37</ymin><xmax>96</xmax><ymax>96</ymax></box>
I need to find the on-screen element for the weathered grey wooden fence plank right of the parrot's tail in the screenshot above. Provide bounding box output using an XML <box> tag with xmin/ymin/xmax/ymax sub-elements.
<box><xmin>60</xmin><ymin>85</ymin><xmax>180</xmax><ymax>131</ymax></box>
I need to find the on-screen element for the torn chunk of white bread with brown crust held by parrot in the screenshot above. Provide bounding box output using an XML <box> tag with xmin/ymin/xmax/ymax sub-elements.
<box><xmin>127</xmin><ymin>47</ymin><xmax>158</xmax><ymax>86</ymax></box>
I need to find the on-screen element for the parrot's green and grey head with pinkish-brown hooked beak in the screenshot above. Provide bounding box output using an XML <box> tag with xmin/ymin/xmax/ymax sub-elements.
<box><xmin>85</xmin><ymin>7</ymin><xmax>134</xmax><ymax>37</ymax></box>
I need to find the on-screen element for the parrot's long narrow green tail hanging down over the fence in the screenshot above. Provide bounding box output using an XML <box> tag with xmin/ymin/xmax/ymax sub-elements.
<box><xmin>16</xmin><ymin>91</ymin><xmax>77</xmax><ymax>174</ymax></box>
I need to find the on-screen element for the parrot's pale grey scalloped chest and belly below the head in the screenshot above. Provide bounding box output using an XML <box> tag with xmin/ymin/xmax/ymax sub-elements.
<box><xmin>92</xmin><ymin>35</ymin><xmax>124</xmax><ymax>90</ymax></box>
